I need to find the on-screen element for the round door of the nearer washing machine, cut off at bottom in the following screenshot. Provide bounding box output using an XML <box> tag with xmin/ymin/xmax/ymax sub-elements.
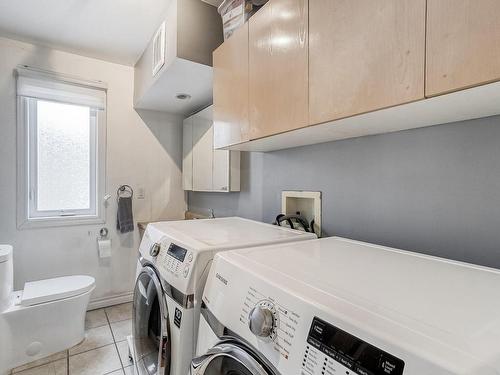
<box><xmin>190</xmin><ymin>343</ymin><xmax>271</xmax><ymax>375</ymax></box>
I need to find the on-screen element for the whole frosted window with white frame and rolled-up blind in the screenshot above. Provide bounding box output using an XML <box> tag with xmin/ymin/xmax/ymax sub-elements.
<box><xmin>17</xmin><ymin>69</ymin><xmax>105</xmax><ymax>227</ymax></box>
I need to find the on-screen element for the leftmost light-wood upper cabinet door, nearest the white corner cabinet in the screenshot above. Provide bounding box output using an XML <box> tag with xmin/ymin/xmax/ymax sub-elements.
<box><xmin>213</xmin><ymin>24</ymin><xmax>249</xmax><ymax>148</ymax></box>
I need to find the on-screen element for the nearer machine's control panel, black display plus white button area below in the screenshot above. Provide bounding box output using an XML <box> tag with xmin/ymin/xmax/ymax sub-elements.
<box><xmin>301</xmin><ymin>317</ymin><xmax>405</xmax><ymax>375</ymax></box>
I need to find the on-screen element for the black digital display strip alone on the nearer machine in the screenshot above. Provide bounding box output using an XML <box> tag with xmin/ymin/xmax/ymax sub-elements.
<box><xmin>307</xmin><ymin>317</ymin><xmax>405</xmax><ymax>375</ymax></box>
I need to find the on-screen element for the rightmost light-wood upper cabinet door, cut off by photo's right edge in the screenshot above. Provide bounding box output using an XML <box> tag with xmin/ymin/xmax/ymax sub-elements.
<box><xmin>426</xmin><ymin>0</ymin><xmax>500</xmax><ymax>96</ymax></box>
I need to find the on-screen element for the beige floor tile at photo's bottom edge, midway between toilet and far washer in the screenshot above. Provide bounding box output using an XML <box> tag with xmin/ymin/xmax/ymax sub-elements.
<box><xmin>69</xmin><ymin>344</ymin><xmax>122</xmax><ymax>375</ymax></box>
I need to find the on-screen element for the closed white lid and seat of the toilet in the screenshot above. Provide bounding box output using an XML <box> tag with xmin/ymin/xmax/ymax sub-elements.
<box><xmin>21</xmin><ymin>275</ymin><xmax>95</xmax><ymax>306</ymax></box>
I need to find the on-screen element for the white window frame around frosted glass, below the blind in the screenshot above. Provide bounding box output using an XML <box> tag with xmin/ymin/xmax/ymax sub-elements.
<box><xmin>17</xmin><ymin>96</ymin><xmax>106</xmax><ymax>229</ymax></box>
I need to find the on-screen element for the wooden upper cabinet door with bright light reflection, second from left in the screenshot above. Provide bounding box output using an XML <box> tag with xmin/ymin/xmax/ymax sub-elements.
<box><xmin>248</xmin><ymin>0</ymin><xmax>308</xmax><ymax>139</ymax></box>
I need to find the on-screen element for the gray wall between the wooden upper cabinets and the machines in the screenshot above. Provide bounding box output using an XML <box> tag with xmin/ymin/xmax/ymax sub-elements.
<box><xmin>189</xmin><ymin>116</ymin><xmax>500</xmax><ymax>268</ymax></box>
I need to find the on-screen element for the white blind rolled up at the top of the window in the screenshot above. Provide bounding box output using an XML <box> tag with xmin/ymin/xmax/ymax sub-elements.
<box><xmin>16</xmin><ymin>67</ymin><xmax>106</xmax><ymax>110</ymax></box>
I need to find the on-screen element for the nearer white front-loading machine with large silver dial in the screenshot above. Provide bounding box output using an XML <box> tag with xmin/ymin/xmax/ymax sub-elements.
<box><xmin>191</xmin><ymin>238</ymin><xmax>500</xmax><ymax>375</ymax></box>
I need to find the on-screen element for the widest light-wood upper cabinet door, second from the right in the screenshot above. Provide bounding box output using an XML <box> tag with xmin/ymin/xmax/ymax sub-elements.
<box><xmin>309</xmin><ymin>0</ymin><xmax>426</xmax><ymax>124</ymax></box>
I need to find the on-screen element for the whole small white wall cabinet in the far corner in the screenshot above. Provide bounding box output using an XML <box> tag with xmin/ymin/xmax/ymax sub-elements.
<box><xmin>182</xmin><ymin>106</ymin><xmax>240</xmax><ymax>192</ymax></box>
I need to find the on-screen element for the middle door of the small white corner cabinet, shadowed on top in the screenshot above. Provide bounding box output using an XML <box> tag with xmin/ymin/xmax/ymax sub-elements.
<box><xmin>193</xmin><ymin>116</ymin><xmax>213</xmax><ymax>191</ymax></box>
